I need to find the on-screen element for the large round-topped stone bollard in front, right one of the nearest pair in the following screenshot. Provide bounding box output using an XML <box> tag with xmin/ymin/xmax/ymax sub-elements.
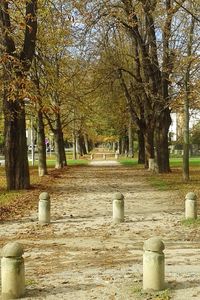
<box><xmin>143</xmin><ymin>237</ymin><xmax>165</xmax><ymax>291</ymax></box>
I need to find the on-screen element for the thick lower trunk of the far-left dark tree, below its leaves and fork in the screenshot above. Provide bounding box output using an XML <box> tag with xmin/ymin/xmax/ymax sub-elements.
<box><xmin>4</xmin><ymin>98</ymin><xmax>30</xmax><ymax>190</ymax></box>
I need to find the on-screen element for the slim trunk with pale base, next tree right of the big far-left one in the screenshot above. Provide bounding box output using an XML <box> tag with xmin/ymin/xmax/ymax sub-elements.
<box><xmin>37</xmin><ymin>109</ymin><xmax>47</xmax><ymax>176</ymax></box>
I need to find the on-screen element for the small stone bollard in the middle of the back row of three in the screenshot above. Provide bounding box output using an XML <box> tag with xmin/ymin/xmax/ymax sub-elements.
<box><xmin>113</xmin><ymin>193</ymin><xmax>124</xmax><ymax>223</ymax></box>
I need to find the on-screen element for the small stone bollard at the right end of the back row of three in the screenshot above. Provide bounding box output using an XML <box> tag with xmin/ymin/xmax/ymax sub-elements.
<box><xmin>185</xmin><ymin>192</ymin><xmax>197</xmax><ymax>219</ymax></box>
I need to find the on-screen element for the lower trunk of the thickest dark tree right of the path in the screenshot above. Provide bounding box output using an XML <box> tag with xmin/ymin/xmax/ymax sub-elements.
<box><xmin>156</xmin><ymin>108</ymin><xmax>171</xmax><ymax>173</ymax></box>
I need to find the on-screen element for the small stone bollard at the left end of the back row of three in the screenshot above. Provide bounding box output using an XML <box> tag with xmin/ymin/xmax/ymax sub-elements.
<box><xmin>39</xmin><ymin>192</ymin><xmax>50</xmax><ymax>224</ymax></box>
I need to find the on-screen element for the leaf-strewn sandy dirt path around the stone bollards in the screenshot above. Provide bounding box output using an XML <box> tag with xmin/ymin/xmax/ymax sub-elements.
<box><xmin>0</xmin><ymin>165</ymin><xmax>200</xmax><ymax>300</ymax></box>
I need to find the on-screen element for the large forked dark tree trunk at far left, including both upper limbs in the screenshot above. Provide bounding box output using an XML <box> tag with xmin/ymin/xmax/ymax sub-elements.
<box><xmin>0</xmin><ymin>0</ymin><xmax>37</xmax><ymax>190</ymax></box>
